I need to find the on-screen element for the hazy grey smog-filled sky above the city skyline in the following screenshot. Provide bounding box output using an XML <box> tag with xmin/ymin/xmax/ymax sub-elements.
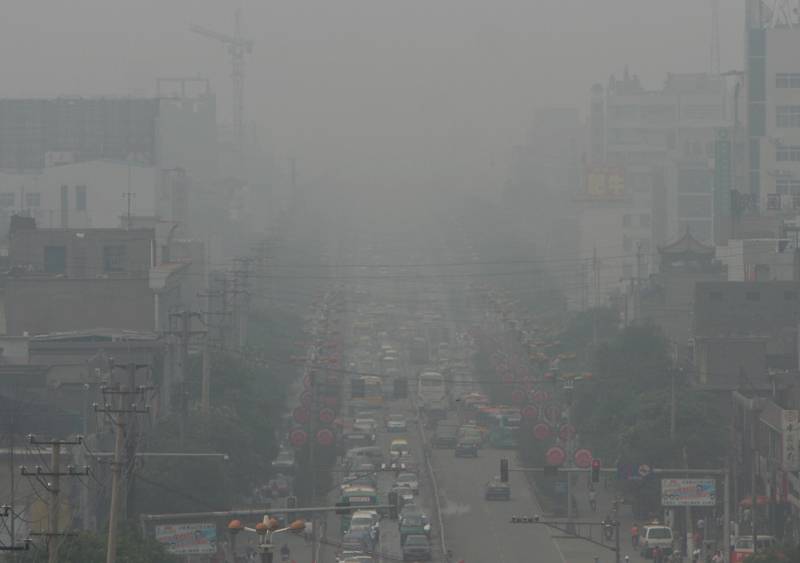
<box><xmin>0</xmin><ymin>0</ymin><xmax>744</xmax><ymax>196</ymax></box>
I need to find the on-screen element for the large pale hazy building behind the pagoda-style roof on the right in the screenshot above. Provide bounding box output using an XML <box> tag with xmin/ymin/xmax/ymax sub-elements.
<box><xmin>579</xmin><ymin>69</ymin><xmax>729</xmax><ymax>306</ymax></box>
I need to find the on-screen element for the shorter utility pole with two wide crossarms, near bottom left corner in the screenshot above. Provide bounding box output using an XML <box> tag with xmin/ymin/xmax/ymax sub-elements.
<box><xmin>20</xmin><ymin>434</ymin><xmax>89</xmax><ymax>563</ymax></box>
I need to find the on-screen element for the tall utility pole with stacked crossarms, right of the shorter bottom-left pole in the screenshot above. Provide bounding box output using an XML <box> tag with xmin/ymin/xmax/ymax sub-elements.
<box><xmin>94</xmin><ymin>363</ymin><xmax>150</xmax><ymax>563</ymax></box>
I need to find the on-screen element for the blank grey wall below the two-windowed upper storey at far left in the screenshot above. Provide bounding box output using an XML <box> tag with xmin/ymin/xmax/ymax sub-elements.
<box><xmin>6</xmin><ymin>276</ymin><xmax>155</xmax><ymax>335</ymax></box>
